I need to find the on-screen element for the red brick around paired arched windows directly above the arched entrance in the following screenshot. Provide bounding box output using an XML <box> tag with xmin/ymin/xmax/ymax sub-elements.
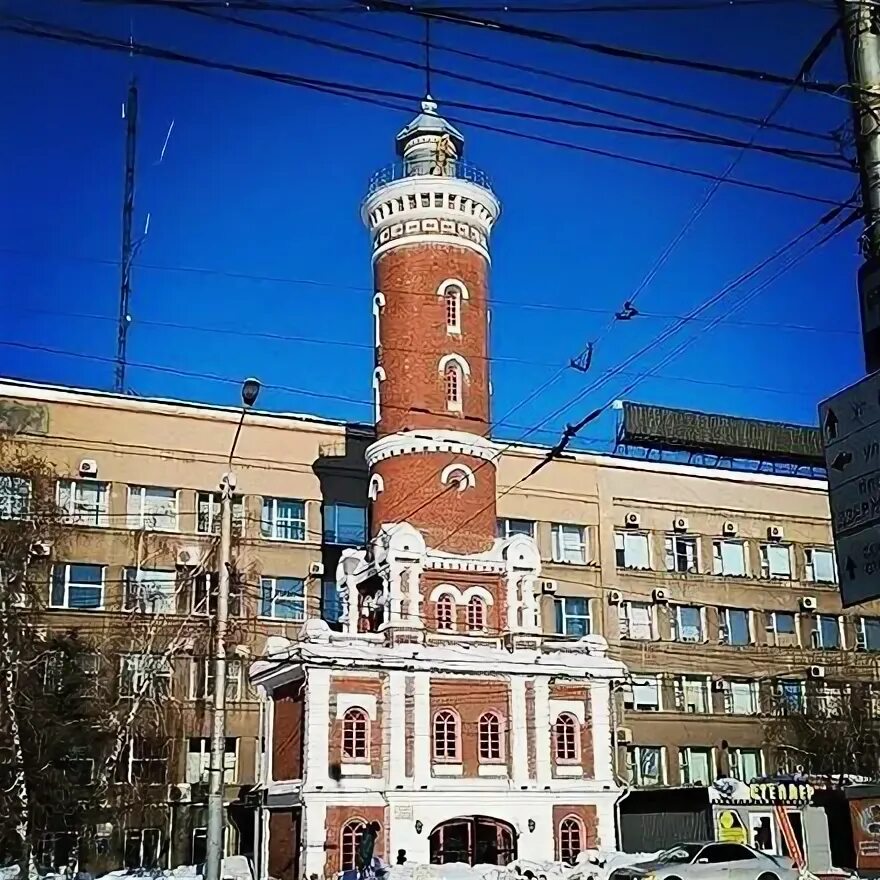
<box><xmin>431</xmin><ymin>677</ymin><xmax>511</xmax><ymax>777</ymax></box>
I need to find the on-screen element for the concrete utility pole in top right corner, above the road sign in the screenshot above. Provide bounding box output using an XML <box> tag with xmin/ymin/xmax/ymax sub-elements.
<box><xmin>838</xmin><ymin>0</ymin><xmax>880</xmax><ymax>373</ymax></box>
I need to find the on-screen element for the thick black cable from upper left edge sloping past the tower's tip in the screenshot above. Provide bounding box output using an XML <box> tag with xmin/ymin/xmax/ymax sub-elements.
<box><xmin>0</xmin><ymin>16</ymin><xmax>852</xmax><ymax>205</ymax></box>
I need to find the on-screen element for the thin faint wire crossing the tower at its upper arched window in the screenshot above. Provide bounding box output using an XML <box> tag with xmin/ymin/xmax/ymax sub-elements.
<box><xmin>0</xmin><ymin>247</ymin><xmax>859</xmax><ymax>336</ymax></box>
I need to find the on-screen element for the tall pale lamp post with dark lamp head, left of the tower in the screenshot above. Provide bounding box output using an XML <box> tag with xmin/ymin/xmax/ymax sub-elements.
<box><xmin>205</xmin><ymin>379</ymin><xmax>260</xmax><ymax>880</ymax></box>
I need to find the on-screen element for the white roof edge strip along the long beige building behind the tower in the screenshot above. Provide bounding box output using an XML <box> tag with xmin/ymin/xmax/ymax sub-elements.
<box><xmin>0</xmin><ymin>377</ymin><xmax>828</xmax><ymax>492</ymax></box>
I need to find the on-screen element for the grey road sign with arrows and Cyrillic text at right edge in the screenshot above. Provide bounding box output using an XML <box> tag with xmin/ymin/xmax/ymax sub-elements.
<box><xmin>819</xmin><ymin>374</ymin><xmax>880</xmax><ymax>607</ymax></box>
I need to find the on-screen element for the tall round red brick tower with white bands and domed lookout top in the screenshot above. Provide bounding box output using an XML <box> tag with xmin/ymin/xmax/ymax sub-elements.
<box><xmin>363</xmin><ymin>97</ymin><xmax>500</xmax><ymax>554</ymax></box>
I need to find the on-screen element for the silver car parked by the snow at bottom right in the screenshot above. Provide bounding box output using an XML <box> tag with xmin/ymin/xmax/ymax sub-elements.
<box><xmin>609</xmin><ymin>843</ymin><xmax>798</xmax><ymax>880</ymax></box>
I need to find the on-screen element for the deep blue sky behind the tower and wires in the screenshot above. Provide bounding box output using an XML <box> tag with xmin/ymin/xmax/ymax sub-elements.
<box><xmin>0</xmin><ymin>0</ymin><xmax>862</xmax><ymax>448</ymax></box>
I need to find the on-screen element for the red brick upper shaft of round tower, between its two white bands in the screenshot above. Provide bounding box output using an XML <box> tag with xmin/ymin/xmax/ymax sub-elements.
<box><xmin>374</xmin><ymin>244</ymin><xmax>489</xmax><ymax>437</ymax></box>
